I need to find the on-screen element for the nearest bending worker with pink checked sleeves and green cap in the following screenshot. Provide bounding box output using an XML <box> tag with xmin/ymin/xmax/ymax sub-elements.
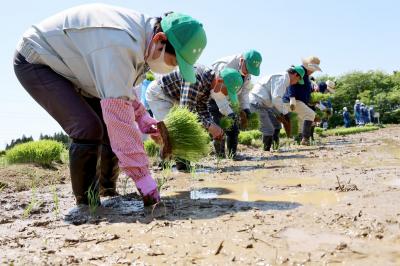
<box><xmin>14</xmin><ymin>4</ymin><xmax>207</xmax><ymax>206</ymax></box>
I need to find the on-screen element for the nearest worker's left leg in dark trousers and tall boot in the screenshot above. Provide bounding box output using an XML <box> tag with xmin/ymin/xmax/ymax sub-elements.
<box><xmin>14</xmin><ymin>53</ymin><xmax>104</xmax><ymax>204</ymax></box>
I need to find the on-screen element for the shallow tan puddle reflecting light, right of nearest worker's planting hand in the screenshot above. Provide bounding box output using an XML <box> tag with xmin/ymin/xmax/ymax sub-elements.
<box><xmin>163</xmin><ymin>179</ymin><xmax>340</xmax><ymax>207</ymax></box>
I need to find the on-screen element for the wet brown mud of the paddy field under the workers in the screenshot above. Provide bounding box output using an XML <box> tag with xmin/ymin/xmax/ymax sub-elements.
<box><xmin>0</xmin><ymin>127</ymin><xmax>400</xmax><ymax>265</ymax></box>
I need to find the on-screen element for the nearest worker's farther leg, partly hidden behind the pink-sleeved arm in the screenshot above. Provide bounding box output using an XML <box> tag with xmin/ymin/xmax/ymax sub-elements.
<box><xmin>84</xmin><ymin>97</ymin><xmax>120</xmax><ymax>196</ymax></box>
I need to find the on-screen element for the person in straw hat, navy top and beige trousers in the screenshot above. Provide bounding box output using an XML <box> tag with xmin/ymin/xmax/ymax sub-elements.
<box><xmin>284</xmin><ymin>56</ymin><xmax>321</xmax><ymax>145</ymax></box>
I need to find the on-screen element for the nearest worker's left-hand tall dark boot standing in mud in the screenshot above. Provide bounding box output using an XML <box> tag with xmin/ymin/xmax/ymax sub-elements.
<box><xmin>69</xmin><ymin>142</ymin><xmax>100</xmax><ymax>205</ymax></box>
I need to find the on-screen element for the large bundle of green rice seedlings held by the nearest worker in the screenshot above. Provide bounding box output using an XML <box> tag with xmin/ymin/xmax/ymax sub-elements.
<box><xmin>164</xmin><ymin>106</ymin><xmax>210</xmax><ymax>162</ymax></box>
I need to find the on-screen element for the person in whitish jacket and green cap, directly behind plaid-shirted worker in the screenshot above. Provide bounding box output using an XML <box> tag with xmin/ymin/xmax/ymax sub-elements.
<box><xmin>209</xmin><ymin>50</ymin><xmax>262</xmax><ymax>160</ymax></box>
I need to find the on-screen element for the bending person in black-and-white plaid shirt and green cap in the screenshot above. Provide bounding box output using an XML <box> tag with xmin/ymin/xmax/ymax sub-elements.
<box><xmin>146</xmin><ymin>65</ymin><xmax>243</xmax><ymax>171</ymax></box>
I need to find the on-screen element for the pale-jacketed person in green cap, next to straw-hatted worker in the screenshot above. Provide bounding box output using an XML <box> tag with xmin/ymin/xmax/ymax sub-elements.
<box><xmin>249</xmin><ymin>66</ymin><xmax>305</xmax><ymax>151</ymax></box>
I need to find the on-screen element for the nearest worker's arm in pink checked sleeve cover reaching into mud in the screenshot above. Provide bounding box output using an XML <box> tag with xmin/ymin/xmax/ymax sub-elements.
<box><xmin>86</xmin><ymin>47</ymin><xmax>160</xmax><ymax>205</ymax></box>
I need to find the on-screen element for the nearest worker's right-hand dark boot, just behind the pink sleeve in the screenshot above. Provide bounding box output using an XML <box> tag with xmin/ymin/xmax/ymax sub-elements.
<box><xmin>99</xmin><ymin>144</ymin><xmax>119</xmax><ymax>197</ymax></box>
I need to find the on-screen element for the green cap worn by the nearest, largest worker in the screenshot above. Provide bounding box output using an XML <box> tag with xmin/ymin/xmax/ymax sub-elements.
<box><xmin>161</xmin><ymin>12</ymin><xmax>207</xmax><ymax>83</ymax></box>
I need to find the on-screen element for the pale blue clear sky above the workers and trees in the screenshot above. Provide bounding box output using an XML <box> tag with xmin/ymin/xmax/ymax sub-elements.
<box><xmin>0</xmin><ymin>0</ymin><xmax>400</xmax><ymax>149</ymax></box>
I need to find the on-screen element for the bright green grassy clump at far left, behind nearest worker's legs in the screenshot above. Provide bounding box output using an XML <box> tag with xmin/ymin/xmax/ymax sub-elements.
<box><xmin>5</xmin><ymin>140</ymin><xmax>65</xmax><ymax>166</ymax></box>
